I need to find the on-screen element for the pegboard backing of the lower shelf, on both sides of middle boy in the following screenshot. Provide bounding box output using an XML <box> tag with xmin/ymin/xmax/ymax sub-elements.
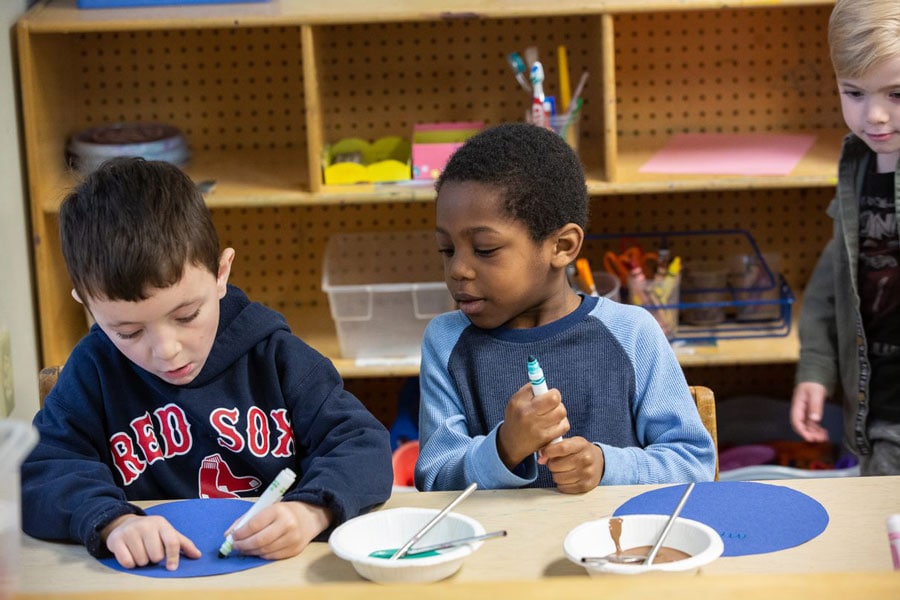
<box><xmin>213</xmin><ymin>188</ymin><xmax>831</xmax><ymax>350</ymax></box>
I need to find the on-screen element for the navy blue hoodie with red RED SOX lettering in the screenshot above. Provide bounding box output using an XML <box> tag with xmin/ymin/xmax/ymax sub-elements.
<box><xmin>22</xmin><ymin>286</ymin><xmax>393</xmax><ymax>556</ymax></box>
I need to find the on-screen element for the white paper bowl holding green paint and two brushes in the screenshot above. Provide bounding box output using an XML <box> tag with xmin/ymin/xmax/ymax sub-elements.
<box><xmin>328</xmin><ymin>508</ymin><xmax>485</xmax><ymax>583</ymax></box>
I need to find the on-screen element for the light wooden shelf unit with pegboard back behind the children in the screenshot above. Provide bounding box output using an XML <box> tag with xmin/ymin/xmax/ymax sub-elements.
<box><xmin>17</xmin><ymin>0</ymin><xmax>844</xmax><ymax>404</ymax></box>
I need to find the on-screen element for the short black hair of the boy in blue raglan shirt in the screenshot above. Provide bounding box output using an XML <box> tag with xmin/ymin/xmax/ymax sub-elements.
<box><xmin>435</xmin><ymin>123</ymin><xmax>588</xmax><ymax>242</ymax></box>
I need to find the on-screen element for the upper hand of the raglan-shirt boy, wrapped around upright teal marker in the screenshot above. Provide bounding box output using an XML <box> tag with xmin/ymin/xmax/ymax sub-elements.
<box><xmin>497</xmin><ymin>383</ymin><xmax>569</xmax><ymax>470</ymax></box>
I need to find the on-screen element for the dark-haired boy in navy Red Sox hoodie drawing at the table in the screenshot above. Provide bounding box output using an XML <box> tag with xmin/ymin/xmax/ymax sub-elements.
<box><xmin>22</xmin><ymin>159</ymin><xmax>393</xmax><ymax>569</ymax></box>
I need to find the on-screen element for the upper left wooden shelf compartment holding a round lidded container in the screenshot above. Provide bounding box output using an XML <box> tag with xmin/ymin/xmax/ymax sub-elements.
<box><xmin>22</xmin><ymin>27</ymin><xmax>309</xmax><ymax>212</ymax></box>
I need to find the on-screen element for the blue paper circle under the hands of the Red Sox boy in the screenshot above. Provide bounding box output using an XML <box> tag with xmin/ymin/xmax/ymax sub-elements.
<box><xmin>100</xmin><ymin>498</ymin><xmax>272</xmax><ymax>578</ymax></box>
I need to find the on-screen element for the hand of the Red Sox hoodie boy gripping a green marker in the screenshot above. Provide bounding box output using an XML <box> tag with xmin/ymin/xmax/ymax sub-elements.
<box><xmin>231</xmin><ymin>501</ymin><xmax>331</xmax><ymax>560</ymax></box>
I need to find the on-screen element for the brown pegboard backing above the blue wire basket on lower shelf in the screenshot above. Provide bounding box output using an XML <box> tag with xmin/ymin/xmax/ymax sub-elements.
<box><xmin>584</xmin><ymin>188</ymin><xmax>833</xmax><ymax>293</ymax></box>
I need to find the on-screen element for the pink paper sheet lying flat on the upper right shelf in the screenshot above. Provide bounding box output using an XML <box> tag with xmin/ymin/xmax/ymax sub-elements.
<box><xmin>639</xmin><ymin>133</ymin><xmax>816</xmax><ymax>175</ymax></box>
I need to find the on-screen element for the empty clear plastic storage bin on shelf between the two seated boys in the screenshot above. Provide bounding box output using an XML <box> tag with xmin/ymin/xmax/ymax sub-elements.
<box><xmin>322</xmin><ymin>231</ymin><xmax>454</xmax><ymax>358</ymax></box>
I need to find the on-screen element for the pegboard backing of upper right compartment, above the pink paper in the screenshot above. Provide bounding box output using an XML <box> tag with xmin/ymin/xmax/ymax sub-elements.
<box><xmin>614</xmin><ymin>6</ymin><xmax>843</xmax><ymax>138</ymax></box>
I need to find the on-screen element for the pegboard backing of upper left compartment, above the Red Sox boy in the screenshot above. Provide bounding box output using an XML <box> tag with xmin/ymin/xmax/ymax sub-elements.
<box><xmin>61</xmin><ymin>27</ymin><xmax>306</xmax><ymax>152</ymax></box>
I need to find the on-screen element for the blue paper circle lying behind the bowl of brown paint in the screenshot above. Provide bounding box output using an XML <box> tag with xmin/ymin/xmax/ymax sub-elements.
<box><xmin>614</xmin><ymin>481</ymin><xmax>828</xmax><ymax>556</ymax></box>
